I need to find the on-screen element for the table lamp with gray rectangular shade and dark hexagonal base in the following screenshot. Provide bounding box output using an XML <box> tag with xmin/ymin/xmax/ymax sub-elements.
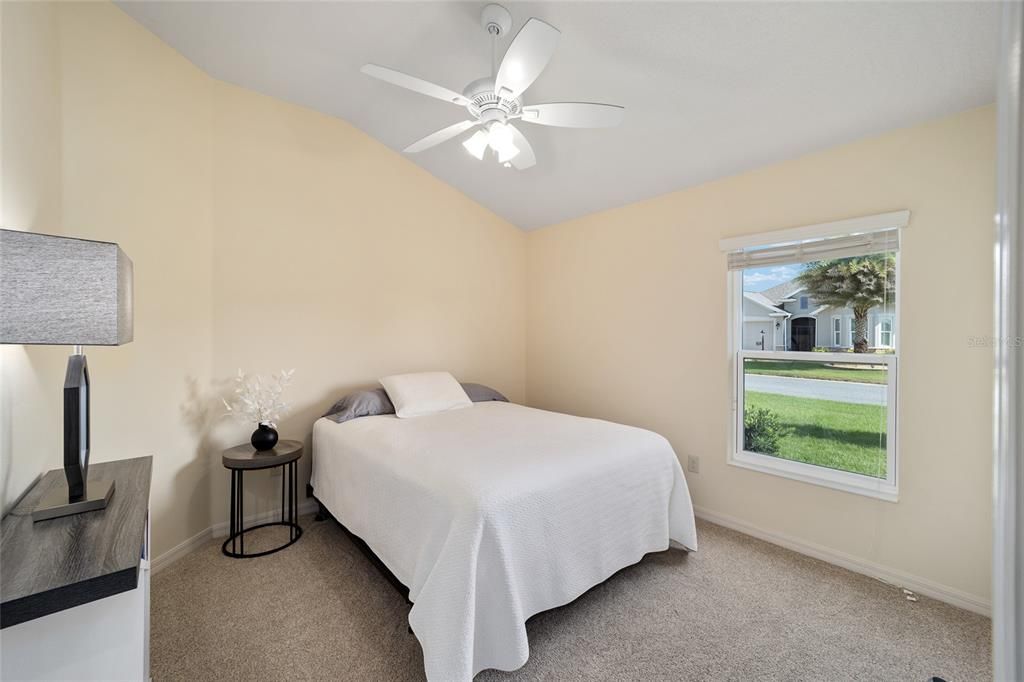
<box><xmin>0</xmin><ymin>229</ymin><xmax>132</xmax><ymax>521</ymax></box>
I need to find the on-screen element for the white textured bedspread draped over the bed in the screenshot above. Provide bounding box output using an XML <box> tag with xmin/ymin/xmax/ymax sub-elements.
<box><xmin>312</xmin><ymin>402</ymin><xmax>697</xmax><ymax>681</ymax></box>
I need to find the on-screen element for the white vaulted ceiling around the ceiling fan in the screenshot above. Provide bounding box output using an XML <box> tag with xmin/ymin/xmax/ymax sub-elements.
<box><xmin>120</xmin><ymin>1</ymin><xmax>1000</xmax><ymax>229</ymax></box>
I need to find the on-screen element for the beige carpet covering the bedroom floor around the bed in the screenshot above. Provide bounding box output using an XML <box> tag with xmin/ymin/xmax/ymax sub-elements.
<box><xmin>152</xmin><ymin>517</ymin><xmax>992</xmax><ymax>682</ymax></box>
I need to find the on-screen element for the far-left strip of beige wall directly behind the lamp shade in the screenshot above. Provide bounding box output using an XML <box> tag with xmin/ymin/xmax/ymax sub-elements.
<box><xmin>0</xmin><ymin>2</ymin><xmax>67</xmax><ymax>513</ymax></box>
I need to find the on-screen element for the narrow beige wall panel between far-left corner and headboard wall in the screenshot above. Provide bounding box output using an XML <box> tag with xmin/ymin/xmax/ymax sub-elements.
<box><xmin>58</xmin><ymin>3</ymin><xmax>214</xmax><ymax>556</ymax></box>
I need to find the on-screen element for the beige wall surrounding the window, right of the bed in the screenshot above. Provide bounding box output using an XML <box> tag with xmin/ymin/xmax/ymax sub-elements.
<box><xmin>526</xmin><ymin>108</ymin><xmax>995</xmax><ymax>603</ymax></box>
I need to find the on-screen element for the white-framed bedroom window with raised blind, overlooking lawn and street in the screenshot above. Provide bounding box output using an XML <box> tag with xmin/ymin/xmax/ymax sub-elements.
<box><xmin>722</xmin><ymin>211</ymin><xmax>909</xmax><ymax>502</ymax></box>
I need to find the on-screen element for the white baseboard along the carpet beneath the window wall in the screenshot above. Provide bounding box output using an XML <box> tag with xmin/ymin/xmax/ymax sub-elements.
<box><xmin>693</xmin><ymin>506</ymin><xmax>992</xmax><ymax>617</ymax></box>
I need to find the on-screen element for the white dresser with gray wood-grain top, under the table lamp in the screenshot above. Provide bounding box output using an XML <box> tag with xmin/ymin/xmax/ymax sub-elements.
<box><xmin>0</xmin><ymin>458</ymin><xmax>152</xmax><ymax>680</ymax></box>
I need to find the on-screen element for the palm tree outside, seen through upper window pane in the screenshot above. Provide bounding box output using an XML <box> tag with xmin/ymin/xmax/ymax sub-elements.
<box><xmin>797</xmin><ymin>254</ymin><xmax>896</xmax><ymax>353</ymax></box>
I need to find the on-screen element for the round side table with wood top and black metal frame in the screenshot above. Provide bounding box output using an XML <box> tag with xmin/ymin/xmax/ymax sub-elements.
<box><xmin>220</xmin><ymin>440</ymin><xmax>302</xmax><ymax>559</ymax></box>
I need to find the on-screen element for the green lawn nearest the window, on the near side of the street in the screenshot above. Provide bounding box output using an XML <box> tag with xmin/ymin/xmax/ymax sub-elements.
<box><xmin>746</xmin><ymin>391</ymin><xmax>886</xmax><ymax>478</ymax></box>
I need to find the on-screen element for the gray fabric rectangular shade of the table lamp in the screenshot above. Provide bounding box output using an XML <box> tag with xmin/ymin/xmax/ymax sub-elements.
<box><xmin>0</xmin><ymin>229</ymin><xmax>133</xmax><ymax>346</ymax></box>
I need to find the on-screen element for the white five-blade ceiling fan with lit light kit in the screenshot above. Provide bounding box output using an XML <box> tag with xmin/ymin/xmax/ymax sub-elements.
<box><xmin>360</xmin><ymin>4</ymin><xmax>625</xmax><ymax>170</ymax></box>
